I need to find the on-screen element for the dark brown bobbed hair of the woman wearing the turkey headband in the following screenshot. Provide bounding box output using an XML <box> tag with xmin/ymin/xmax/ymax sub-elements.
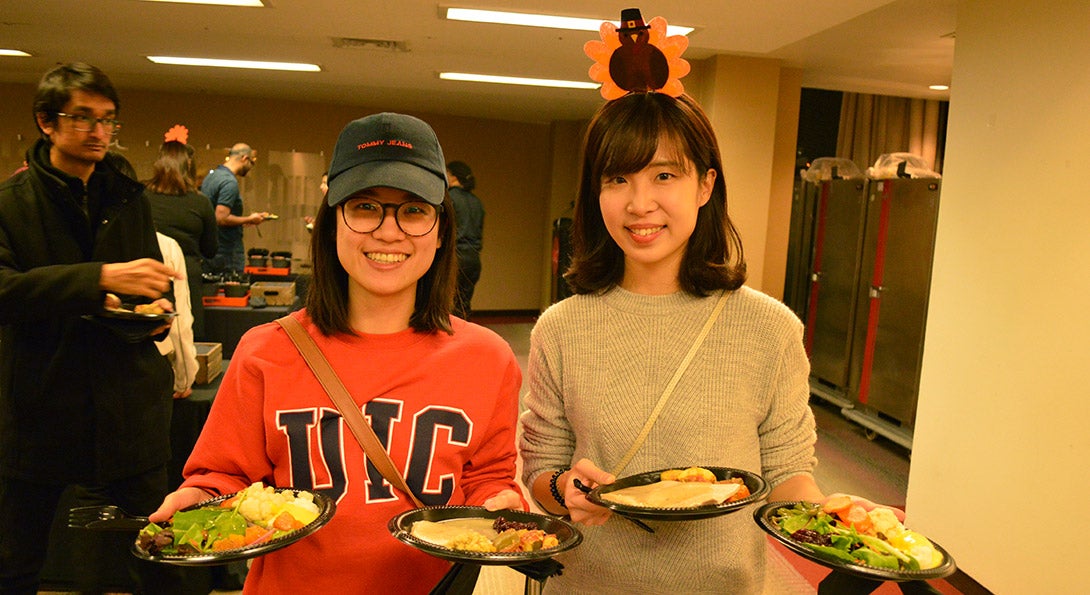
<box><xmin>564</xmin><ymin>93</ymin><xmax>746</xmax><ymax>296</ymax></box>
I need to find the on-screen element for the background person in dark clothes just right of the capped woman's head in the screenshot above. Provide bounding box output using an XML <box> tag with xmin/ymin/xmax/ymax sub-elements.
<box><xmin>447</xmin><ymin>156</ymin><xmax>484</xmax><ymax>313</ymax></box>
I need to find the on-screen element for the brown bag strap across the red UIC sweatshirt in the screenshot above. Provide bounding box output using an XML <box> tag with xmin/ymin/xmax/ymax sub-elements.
<box><xmin>277</xmin><ymin>315</ymin><xmax>424</xmax><ymax>508</ymax></box>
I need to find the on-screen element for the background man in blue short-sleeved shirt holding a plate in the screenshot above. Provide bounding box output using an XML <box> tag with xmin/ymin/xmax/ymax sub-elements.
<box><xmin>201</xmin><ymin>143</ymin><xmax>269</xmax><ymax>275</ymax></box>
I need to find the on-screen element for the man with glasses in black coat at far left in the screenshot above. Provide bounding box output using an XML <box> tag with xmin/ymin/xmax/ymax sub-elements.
<box><xmin>0</xmin><ymin>63</ymin><xmax>179</xmax><ymax>594</ymax></box>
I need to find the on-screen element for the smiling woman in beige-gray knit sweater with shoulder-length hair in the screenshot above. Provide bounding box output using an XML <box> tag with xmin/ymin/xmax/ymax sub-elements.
<box><xmin>520</xmin><ymin>93</ymin><xmax>885</xmax><ymax>593</ymax></box>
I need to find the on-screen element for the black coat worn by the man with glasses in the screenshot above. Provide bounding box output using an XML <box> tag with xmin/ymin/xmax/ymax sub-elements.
<box><xmin>0</xmin><ymin>141</ymin><xmax>173</xmax><ymax>484</ymax></box>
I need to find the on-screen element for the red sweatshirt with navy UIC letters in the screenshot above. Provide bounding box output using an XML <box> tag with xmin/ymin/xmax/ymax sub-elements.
<box><xmin>183</xmin><ymin>312</ymin><xmax>525</xmax><ymax>595</ymax></box>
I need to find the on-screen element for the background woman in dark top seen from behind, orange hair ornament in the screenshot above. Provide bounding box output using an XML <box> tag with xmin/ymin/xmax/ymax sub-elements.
<box><xmin>144</xmin><ymin>132</ymin><xmax>219</xmax><ymax>338</ymax></box>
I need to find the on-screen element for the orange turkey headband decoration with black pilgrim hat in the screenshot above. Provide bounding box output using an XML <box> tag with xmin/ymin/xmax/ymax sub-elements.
<box><xmin>583</xmin><ymin>9</ymin><xmax>689</xmax><ymax>100</ymax></box>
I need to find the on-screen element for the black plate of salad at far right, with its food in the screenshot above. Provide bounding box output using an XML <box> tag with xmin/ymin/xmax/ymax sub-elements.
<box><xmin>753</xmin><ymin>501</ymin><xmax>957</xmax><ymax>582</ymax></box>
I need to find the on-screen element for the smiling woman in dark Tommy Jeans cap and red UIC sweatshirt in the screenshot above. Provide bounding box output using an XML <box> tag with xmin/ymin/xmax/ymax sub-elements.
<box><xmin>152</xmin><ymin>113</ymin><xmax>524</xmax><ymax>594</ymax></box>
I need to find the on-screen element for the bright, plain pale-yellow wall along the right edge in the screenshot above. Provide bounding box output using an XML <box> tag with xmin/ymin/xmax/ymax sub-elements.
<box><xmin>907</xmin><ymin>0</ymin><xmax>1090</xmax><ymax>593</ymax></box>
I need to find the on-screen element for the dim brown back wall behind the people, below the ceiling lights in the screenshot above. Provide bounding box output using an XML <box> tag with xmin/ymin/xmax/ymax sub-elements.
<box><xmin>0</xmin><ymin>84</ymin><xmax>554</xmax><ymax>311</ymax></box>
